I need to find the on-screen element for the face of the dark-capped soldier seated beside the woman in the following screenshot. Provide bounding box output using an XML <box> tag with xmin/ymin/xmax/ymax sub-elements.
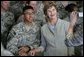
<box><xmin>24</xmin><ymin>9</ymin><xmax>34</xmax><ymax>23</ymax></box>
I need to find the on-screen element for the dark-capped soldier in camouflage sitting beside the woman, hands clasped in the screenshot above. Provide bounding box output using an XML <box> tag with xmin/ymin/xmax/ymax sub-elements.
<box><xmin>7</xmin><ymin>6</ymin><xmax>40</xmax><ymax>56</ymax></box>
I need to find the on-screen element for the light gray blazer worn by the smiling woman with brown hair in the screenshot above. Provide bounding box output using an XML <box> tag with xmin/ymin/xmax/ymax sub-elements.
<box><xmin>41</xmin><ymin>19</ymin><xmax>74</xmax><ymax>56</ymax></box>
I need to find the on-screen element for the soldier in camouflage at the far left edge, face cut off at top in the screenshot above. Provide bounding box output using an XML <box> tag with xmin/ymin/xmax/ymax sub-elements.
<box><xmin>1</xmin><ymin>1</ymin><xmax>15</xmax><ymax>48</ymax></box>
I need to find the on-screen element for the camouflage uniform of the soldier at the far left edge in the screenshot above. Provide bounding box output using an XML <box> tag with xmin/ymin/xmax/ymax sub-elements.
<box><xmin>1</xmin><ymin>11</ymin><xmax>14</xmax><ymax>46</ymax></box>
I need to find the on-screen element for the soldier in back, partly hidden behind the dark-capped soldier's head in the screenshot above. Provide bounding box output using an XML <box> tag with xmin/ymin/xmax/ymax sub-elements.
<box><xmin>17</xmin><ymin>1</ymin><xmax>45</xmax><ymax>26</ymax></box>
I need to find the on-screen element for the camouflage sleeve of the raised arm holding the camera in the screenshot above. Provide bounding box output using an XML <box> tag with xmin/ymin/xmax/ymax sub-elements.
<box><xmin>65</xmin><ymin>23</ymin><xmax>83</xmax><ymax>46</ymax></box>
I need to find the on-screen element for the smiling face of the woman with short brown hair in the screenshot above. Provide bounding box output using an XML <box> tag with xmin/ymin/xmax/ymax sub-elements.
<box><xmin>47</xmin><ymin>6</ymin><xmax>57</xmax><ymax>19</ymax></box>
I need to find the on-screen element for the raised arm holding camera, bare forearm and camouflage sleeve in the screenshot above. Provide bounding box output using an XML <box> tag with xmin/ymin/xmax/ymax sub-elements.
<box><xmin>65</xmin><ymin>12</ymin><xmax>83</xmax><ymax>46</ymax></box>
